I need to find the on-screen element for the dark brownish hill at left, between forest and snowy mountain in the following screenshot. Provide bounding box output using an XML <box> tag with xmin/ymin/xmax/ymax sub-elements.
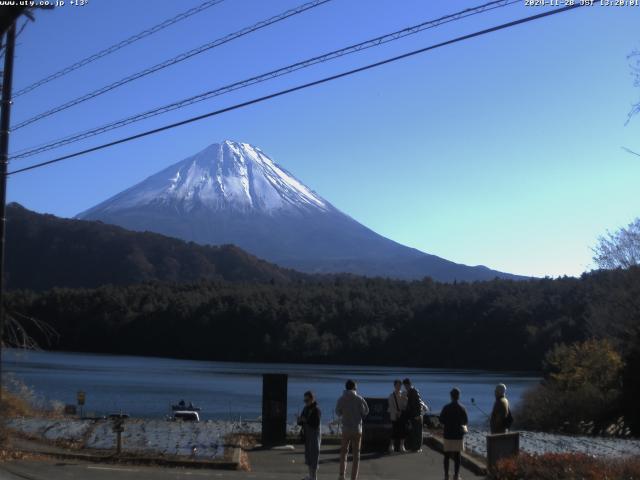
<box><xmin>6</xmin><ymin>203</ymin><xmax>305</xmax><ymax>290</ymax></box>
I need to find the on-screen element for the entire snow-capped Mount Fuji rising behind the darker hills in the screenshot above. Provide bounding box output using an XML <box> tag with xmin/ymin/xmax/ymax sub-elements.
<box><xmin>77</xmin><ymin>141</ymin><xmax>523</xmax><ymax>281</ymax></box>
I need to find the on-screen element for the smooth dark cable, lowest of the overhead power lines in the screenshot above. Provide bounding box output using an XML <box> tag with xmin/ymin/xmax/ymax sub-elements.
<box><xmin>7</xmin><ymin>3</ymin><xmax>584</xmax><ymax>175</ymax></box>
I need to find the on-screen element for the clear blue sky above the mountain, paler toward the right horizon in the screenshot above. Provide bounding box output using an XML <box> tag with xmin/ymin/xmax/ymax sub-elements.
<box><xmin>8</xmin><ymin>0</ymin><xmax>640</xmax><ymax>276</ymax></box>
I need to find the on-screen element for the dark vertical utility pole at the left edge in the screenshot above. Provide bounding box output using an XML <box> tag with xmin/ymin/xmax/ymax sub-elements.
<box><xmin>0</xmin><ymin>22</ymin><xmax>16</xmax><ymax>404</ymax></box>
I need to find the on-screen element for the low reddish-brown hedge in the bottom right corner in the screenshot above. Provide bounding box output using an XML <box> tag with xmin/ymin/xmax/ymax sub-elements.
<box><xmin>492</xmin><ymin>453</ymin><xmax>640</xmax><ymax>480</ymax></box>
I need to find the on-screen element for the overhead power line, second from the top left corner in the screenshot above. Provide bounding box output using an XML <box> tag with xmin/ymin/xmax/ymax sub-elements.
<box><xmin>12</xmin><ymin>0</ymin><xmax>331</xmax><ymax>130</ymax></box>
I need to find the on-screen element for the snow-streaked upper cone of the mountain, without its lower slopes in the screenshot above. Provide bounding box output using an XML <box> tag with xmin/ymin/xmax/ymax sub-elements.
<box><xmin>81</xmin><ymin>140</ymin><xmax>331</xmax><ymax>216</ymax></box>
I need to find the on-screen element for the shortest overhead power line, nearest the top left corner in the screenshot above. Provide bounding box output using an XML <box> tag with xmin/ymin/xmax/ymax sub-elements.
<box><xmin>13</xmin><ymin>0</ymin><xmax>224</xmax><ymax>98</ymax></box>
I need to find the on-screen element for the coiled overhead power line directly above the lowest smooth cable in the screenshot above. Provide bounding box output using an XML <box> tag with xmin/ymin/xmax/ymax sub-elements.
<box><xmin>11</xmin><ymin>0</ymin><xmax>521</xmax><ymax>160</ymax></box>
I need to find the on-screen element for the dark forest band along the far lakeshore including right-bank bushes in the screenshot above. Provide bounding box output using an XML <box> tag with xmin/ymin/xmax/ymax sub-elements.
<box><xmin>7</xmin><ymin>267</ymin><xmax>640</xmax><ymax>434</ymax></box>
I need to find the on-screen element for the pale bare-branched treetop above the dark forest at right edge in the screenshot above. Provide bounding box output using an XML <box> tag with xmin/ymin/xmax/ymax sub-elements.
<box><xmin>593</xmin><ymin>217</ymin><xmax>640</xmax><ymax>269</ymax></box>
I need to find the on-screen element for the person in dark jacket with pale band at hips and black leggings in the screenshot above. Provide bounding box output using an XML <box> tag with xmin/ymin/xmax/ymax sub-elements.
<box><xmin>440</xmin><ymin>388</ymin><xmax>469</xmax><ymax>480</ymax></box>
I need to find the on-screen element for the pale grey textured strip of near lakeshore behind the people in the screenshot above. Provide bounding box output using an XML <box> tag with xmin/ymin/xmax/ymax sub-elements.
<box><xmin>7</xmin><ymin>417</ymin><xmax>640</xmax><ymax>460</ymax></box>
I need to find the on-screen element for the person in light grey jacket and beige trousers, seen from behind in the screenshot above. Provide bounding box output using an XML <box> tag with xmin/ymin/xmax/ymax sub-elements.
<box><xmin>336</xmin><ymin>380</ymin><xmax>369</xmax><ymax>480</ymax></box>
